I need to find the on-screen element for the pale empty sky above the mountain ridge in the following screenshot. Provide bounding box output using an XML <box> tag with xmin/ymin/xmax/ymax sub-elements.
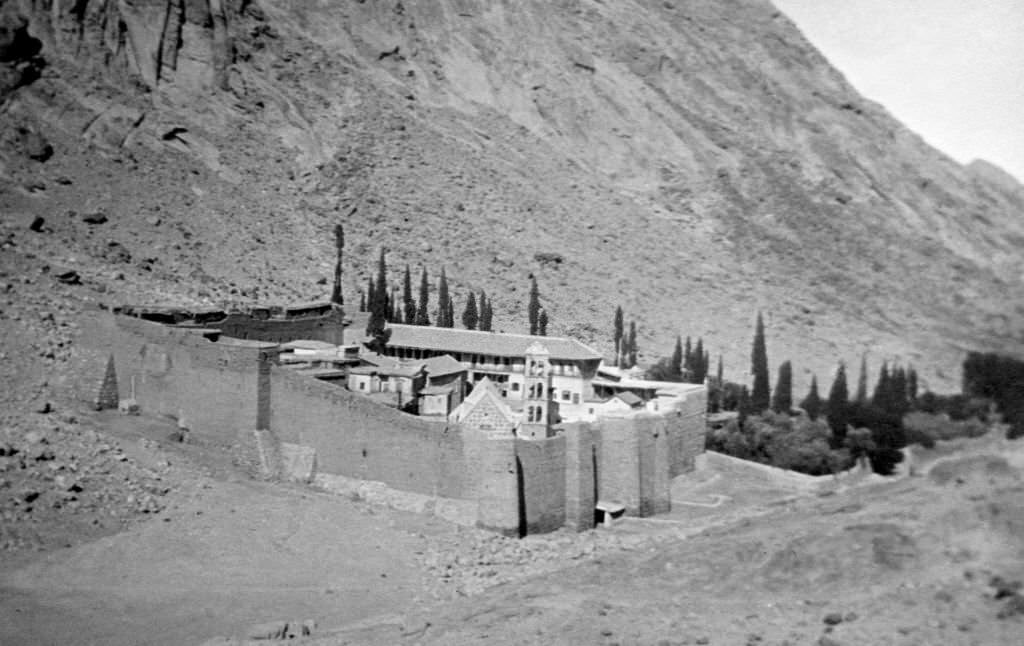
<box><xmin>772</xmin><ymin>0</ymin><xmax>1024</xmax><ymax>182</ymax></box>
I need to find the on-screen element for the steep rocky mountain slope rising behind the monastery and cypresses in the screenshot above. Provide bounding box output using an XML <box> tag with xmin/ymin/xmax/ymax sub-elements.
<box><xmin>0</xmin><ymin>0</ymin><xmax>1024</xmax><ymax>389</ymax></box>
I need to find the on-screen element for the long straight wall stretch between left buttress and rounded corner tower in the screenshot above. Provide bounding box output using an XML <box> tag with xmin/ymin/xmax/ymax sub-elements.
<box><xmin>269</xmin><ymin>365</ymin><xmax>466</xmax><ymax>498</ymax></box>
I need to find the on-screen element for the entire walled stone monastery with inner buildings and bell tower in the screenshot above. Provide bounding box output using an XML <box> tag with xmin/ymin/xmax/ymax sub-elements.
<box><xmin>78</xmin><ymin>303</ymin><xmax>707</xmax><ymax>535</ymax></box>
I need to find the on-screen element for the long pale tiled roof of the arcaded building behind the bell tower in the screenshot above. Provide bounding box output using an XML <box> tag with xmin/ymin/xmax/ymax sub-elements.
<box><xmin>378</xmin><ymin>324</ymin><xmax>601</xmax><ymax>361</ymax></box>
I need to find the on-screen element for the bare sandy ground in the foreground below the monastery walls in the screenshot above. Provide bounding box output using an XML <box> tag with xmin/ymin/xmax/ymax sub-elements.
<box><xmin>0</xmin><ymin>407</ymin><xmax>1024</xmax><ymax>646</ymax></box>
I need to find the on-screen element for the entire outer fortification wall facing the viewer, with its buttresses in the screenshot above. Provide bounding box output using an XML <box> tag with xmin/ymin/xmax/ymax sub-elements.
<box><xmin>72</xmin><ymin>316</ymin><xmax>706</xmax><ymax>535</ymax></box>
